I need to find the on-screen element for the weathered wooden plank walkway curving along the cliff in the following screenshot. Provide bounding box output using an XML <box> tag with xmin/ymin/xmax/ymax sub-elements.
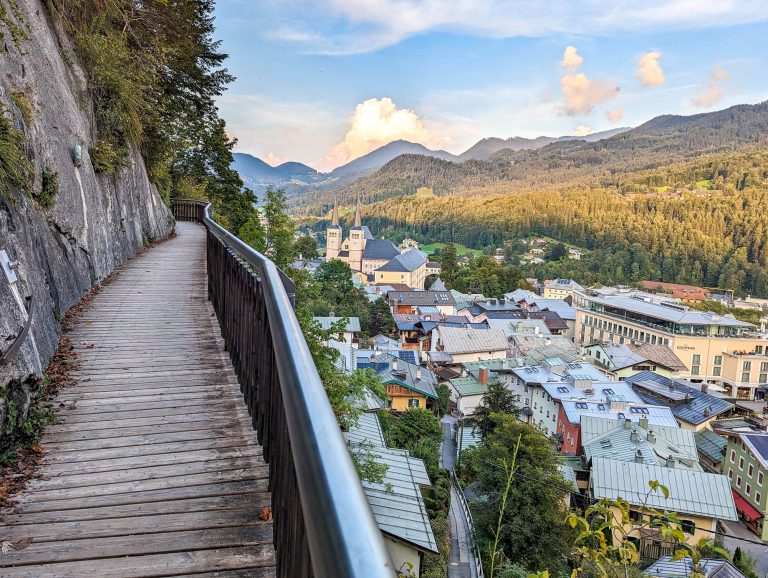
<box><xmin>0</xmin><ymin>223</ymin><xmax>275</xmax><ymax>578</ymax></box>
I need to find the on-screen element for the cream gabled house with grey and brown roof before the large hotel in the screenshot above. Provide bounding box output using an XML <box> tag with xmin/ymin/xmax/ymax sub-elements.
<box><xmin>584</xmin><ymin>341</ymin><xmax>688</xmax><ymax>379</ymax></box>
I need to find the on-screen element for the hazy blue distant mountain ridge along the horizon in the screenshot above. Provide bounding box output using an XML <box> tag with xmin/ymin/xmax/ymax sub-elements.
<box><xmin>232</xmin><ymin>127</ymin><xmax>630</xmax><ymax>197</ymax></box>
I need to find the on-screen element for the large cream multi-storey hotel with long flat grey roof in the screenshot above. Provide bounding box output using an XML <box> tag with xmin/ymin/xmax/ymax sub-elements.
<box><xmin>575</xmin><ymin>291</ymin><xmax>768</xmax><ymax>399</ymax></box>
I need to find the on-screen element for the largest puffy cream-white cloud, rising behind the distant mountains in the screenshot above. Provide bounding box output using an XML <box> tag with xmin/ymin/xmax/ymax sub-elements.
<box><xmin>323</xmin><ymin>97</ymin><xmax>446</xmax><ymax>167</ymax></box>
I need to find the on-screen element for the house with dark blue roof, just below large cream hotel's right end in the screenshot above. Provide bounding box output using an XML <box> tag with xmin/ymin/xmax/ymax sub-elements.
<box><xmin>624</xmin><ymin>371</ymin><xmax>734</xmax><ymax>431</ymax></box>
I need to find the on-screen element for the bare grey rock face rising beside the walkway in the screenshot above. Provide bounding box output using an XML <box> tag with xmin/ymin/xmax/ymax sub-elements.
<box><xmin>0</xmin><ymin>0</ymin><xmax>173</xmax><ymax>387</ymax></box>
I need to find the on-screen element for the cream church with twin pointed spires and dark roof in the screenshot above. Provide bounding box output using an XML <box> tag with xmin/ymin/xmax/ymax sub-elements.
<box><xmin>325</xmin><ymin>199</ymin><xmax>427</xmax><ymax>289</ymax></box>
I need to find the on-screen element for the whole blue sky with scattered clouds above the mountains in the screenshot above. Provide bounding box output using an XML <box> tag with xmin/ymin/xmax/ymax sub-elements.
<box><xmin>215</xmin><ymin>0</ymin><xmax>768</xmax><ymax>171</ymax></box>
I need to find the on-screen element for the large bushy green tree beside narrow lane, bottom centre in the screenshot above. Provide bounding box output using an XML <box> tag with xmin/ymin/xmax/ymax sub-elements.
<box><xmin>462</xmin><ymin>414</ymin><xmax>574</xmax><ymax>572</ymax></box>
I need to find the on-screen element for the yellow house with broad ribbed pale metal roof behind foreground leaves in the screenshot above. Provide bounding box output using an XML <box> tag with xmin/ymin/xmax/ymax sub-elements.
<box><xmin>589</xmin><ymin>457</ymin><xmax>738</xmax><ymax>556</ymax></box>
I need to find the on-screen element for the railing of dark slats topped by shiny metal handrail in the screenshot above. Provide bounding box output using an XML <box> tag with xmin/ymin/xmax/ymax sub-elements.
<box><xmin>171</xmin><ymin>199</ymin><xmax>395</xmax><ymax>578</ymax></box>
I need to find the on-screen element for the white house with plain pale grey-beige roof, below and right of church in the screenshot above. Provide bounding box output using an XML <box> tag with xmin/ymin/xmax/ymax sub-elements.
<box><xmin>432</xmin><ymin>326</ymin><xmax>509</xmax><ymax>364</ymax></box>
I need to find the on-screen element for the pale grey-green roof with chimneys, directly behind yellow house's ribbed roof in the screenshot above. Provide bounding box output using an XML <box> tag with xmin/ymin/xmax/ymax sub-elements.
<box><xmin>581</xmin><ymin>417</ymin><xmax>702</xmax><ymax>471</ymax></box>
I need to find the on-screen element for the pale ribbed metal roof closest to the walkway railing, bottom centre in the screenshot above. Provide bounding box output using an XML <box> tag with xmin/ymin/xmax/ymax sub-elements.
<box><xmin>356</xmin><ymin>448</ymin><xmax>437</xmax><ymax>552</ymax></box>
